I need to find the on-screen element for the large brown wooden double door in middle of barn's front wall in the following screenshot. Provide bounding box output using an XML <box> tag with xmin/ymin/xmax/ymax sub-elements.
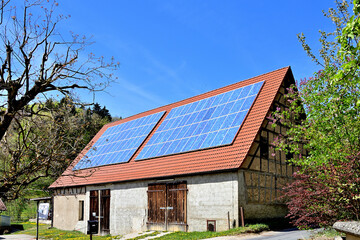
<box><xmin>148</xmin><ymin>182</ymin><xmax>187</xmax><ymax>230</ymax></box>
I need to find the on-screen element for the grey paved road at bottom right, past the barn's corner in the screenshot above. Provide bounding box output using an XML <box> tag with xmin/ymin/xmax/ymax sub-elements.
<box><xmin>209</xmin><ymin>229</ymin><xmax>314</xmax><ymax>240</ymax></box>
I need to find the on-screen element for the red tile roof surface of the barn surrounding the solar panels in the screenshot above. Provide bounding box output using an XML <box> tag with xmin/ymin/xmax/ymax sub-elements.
<box><xmin>50</xmin><ymin>67</ymin><xmax>293</xmax><ymax>188</ymax></box>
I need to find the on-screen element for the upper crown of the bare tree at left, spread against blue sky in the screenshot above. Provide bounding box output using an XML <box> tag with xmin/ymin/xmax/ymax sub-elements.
<box><xmin>0</xmin><ymin>0</ymin><xmax>118</xmax><ymax>140</ymax></box>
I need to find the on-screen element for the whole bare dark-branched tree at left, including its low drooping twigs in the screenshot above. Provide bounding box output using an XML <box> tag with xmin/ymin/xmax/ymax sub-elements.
<box><xmin>0</xmin><ymin>0</ymin><xmax>118</xmax><ymax>199</ymax></box>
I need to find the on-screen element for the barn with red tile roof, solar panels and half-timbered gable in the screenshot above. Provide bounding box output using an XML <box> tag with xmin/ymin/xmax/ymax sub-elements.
<box><xmin>50</xmin><ymin>67</ymin><xmax>294</xmax><ymax>235</ymax></box>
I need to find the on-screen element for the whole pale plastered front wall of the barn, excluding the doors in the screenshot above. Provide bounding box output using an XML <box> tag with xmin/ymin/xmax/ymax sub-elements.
<box><xmin>54</xmin><ymin>172</ymin><xmax>239</xmax><ymax>235</ymax></box>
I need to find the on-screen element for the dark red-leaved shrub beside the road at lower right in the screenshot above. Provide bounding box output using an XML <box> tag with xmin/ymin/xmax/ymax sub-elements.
<box><xmin>284</xmin><ymin>153</ymin><xmax>360</xmax><ymax>228</ymax></box>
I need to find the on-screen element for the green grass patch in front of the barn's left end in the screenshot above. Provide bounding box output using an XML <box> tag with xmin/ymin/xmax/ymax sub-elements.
<box><xmin>14</xmin><ymin>222</ymin><xmax>120</xmax><ymax>240</ymax></box>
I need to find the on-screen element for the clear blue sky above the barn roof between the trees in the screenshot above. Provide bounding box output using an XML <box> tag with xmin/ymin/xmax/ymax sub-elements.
<box><xmin>54</xmin><ymin>0</ymin><xmax>334</xmax><ymax>117</ymax></box>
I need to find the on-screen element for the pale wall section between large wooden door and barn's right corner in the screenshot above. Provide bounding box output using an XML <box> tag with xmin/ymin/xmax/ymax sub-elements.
<box><xmin>186</xmin><ymin>173</ymin><xmax>239</xmax><ymax>231</ymax></box>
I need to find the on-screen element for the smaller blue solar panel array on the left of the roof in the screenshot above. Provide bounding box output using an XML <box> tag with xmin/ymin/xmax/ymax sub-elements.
<box><xmin>73</xmin><ymin>112</ymin><xmax>165</xmax><ymax>170</ymax></box>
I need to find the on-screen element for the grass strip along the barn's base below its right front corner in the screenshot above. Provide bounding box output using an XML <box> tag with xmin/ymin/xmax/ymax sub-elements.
<box><xmin>156</xmin><ymin>224</ymin><xmax>269</xmax><ymax>240</ymax></box>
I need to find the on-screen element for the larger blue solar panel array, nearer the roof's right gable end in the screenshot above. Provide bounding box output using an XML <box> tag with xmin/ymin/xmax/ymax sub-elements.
<box><xmin>135</xmin><ymin>82</ymin><xmax>264</xmax><ymax>160</ymax></box>
